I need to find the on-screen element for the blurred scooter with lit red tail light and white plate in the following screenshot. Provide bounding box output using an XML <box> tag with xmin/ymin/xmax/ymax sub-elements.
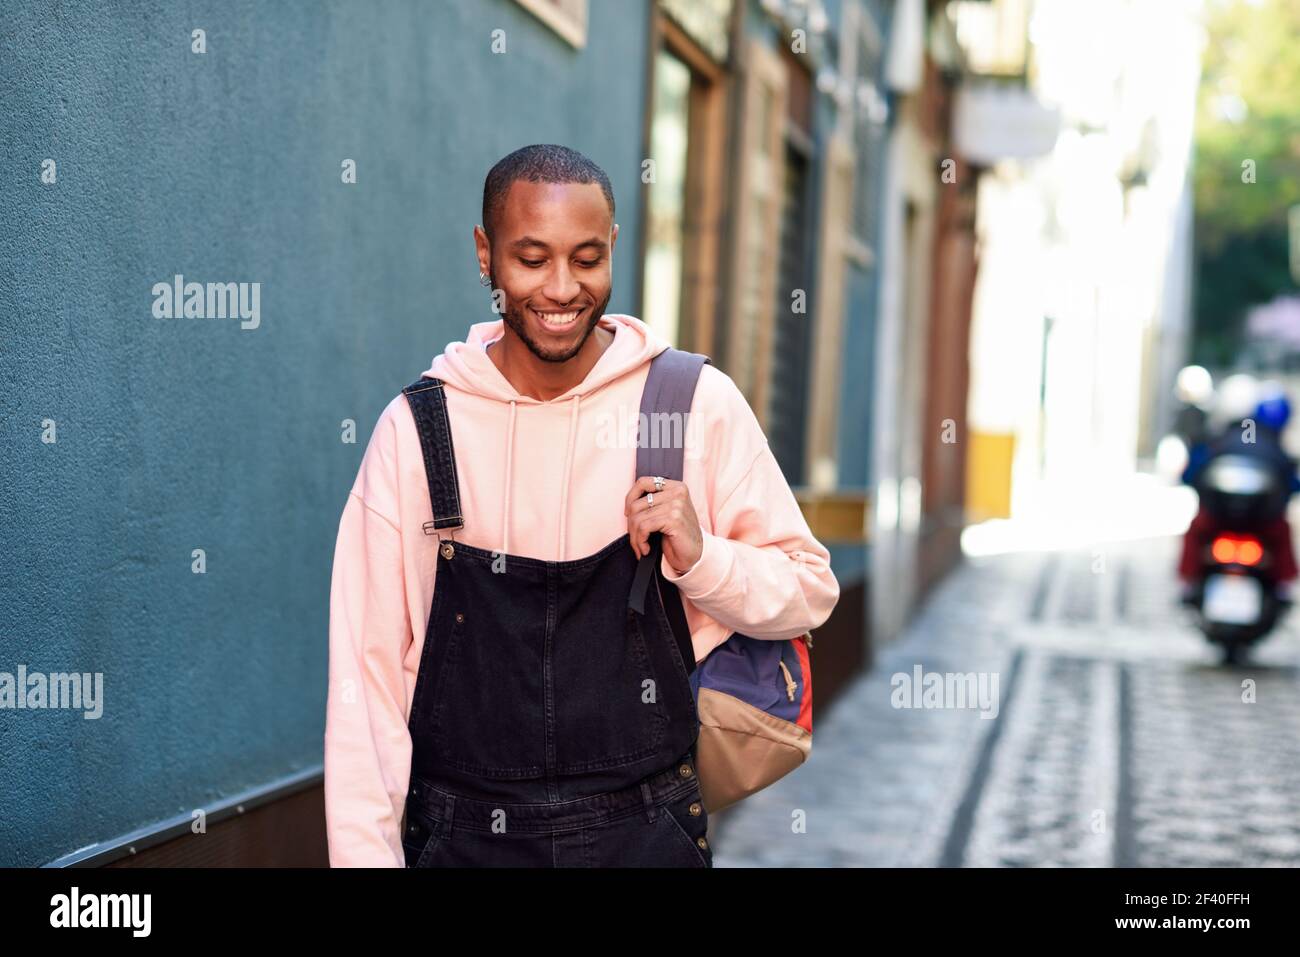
<box><xmin>1191</xmin><ymin>455</ymin><xmax>1291</xmax><ymax>664</ymax></box>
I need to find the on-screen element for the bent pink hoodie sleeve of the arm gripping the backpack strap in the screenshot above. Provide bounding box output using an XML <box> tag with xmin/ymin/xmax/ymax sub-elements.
<box><xmin>660</xmin><ymin>365</ymin><xmax>840</xmax><ymax>640</ymax></box>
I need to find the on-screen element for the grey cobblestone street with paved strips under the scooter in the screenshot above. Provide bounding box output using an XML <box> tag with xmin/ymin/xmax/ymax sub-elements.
<box><xmin>715</xmin><ymin>527</ymin><xmax>1300</xmax><ymax>867</ymax></box>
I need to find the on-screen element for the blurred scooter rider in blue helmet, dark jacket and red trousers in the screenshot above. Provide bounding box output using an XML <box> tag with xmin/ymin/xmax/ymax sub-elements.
<box><xmin>1178</xmin><ymin>386</ymin><xmax>1300</xmax><ymax>605</ymax></box>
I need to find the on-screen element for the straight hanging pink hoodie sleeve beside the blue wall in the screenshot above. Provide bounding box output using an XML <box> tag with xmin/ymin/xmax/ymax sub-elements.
<box><xmin>325</xmin><ymin>403</ymin><xmax>411</xmax><ymax>867</ymax></box>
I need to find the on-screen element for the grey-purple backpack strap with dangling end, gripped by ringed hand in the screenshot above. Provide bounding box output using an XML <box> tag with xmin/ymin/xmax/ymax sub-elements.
<box><xmin>628</xmin><ymin>347</ymin><xmax>711</xmax><ymax>675</ymax></box>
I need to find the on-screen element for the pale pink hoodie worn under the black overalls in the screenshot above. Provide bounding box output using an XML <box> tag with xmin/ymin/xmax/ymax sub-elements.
<box><xmin>325</xmin><ymin>315</ymin><xmax>840</xmax><ymax>867</ymax></box>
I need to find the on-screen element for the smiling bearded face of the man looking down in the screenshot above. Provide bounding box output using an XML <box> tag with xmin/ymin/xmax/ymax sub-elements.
<box><xmin>475</xmin><ymin>179</ymin><xmax>619</xmax><ymax>363</ymax></box>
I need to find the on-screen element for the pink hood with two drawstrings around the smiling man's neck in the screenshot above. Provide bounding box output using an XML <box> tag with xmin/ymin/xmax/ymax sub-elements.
<box><xmin>424</xmin><ymin>313</ymin><xmax>670</xmax><ymax>555</ymax></box>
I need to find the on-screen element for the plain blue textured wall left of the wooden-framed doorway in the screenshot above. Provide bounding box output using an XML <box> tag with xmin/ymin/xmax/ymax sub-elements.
<box><xmin>0</xmin><ymin>0</ymin><xmax>647</xmax><ymax>865</ymax></box>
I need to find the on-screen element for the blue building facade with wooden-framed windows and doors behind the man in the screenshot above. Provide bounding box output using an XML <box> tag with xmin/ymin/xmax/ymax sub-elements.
<box><xmin>0</xmin><ymin>0</ymin><xmax>979</xmax><ymax>866</ymax></box>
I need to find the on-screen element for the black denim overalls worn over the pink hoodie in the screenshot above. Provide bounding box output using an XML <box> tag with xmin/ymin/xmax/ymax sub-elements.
<box><xmin>402</xmin><ymin>378</ymin><xmax>712</xmax><ymax>867</ymax></box>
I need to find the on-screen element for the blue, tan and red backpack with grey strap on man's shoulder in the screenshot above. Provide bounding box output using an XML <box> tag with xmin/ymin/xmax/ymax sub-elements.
<box><xmin>628</xmin><ymin>348</ymin><xmax>813</xmax><ymax>813</ymax></box>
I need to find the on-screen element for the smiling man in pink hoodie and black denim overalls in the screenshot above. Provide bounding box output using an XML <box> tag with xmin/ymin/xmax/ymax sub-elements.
<box><xmin>325</xmin><ymin>146</ymin><xmax>840</xmax><ymax>867</ymax></box>
